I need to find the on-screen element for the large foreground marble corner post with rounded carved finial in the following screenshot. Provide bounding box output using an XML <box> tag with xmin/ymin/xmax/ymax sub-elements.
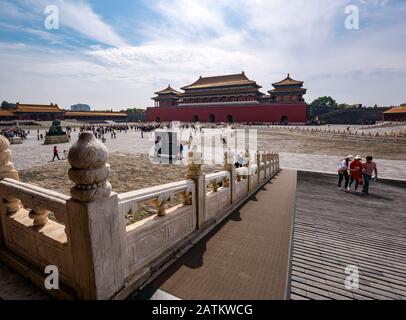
<box><xmin>66</xmin><ymin>131</ymin><xmax>128</xmax><ymax>299</ymax></box>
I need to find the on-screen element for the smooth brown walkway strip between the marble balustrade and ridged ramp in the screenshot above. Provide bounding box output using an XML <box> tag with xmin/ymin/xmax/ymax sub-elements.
<box><xmin>135</xmin><ymin>170</ymin><xmax>296</xmax><ymax>300</ymax></box>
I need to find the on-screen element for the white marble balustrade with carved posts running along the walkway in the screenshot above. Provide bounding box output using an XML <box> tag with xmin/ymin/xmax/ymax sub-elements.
<box><xmin>0</xmin><ymin>132</ymin><xmax>279</xmax><ymax>299</ymax></box>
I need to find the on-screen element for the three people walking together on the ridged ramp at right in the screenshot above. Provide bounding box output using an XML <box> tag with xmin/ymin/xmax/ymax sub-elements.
<box><xmin>338</xmin><ymin>155</ymin><xmax>378</xmax><ymax>195</ymax></box>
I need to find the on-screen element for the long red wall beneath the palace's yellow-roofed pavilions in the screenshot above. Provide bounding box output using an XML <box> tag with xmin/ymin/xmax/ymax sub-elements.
<box><xmin>146</xmin><ymin>103</ymin><xmax>307</xmax><ymax>123</ymax></box>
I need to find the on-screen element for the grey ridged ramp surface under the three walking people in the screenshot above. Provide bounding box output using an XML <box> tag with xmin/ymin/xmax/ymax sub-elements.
<box><xmin>290</xmin><ymin>172</ymin><xmax>406</xmax><ymax>300</ymax></box>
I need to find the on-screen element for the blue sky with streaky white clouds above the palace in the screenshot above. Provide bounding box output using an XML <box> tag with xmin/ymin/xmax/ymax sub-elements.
<box><xmin>0</xmin><ymin>0</ymin><xmax>406</xmax><ymax>110</ymax></box>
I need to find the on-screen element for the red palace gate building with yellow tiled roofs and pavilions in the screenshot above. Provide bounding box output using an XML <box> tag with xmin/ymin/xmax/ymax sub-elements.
<box><xmin>146</xmin><ymin>72</ymin><xmax>307</xmax><ymax>124</ymax></box>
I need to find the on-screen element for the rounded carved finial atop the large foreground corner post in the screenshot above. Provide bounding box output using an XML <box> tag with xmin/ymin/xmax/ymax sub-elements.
<box><xmin>68</xmin><ymin>131</ymin><xmax>111</xmax><ymax>202</ymax></box>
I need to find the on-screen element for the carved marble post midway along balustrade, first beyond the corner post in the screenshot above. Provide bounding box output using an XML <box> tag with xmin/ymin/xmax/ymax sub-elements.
<box><xmin>185</xmin><ymin>145</ymin><xmax>206</xmax><ymax>229</ymax></box>
